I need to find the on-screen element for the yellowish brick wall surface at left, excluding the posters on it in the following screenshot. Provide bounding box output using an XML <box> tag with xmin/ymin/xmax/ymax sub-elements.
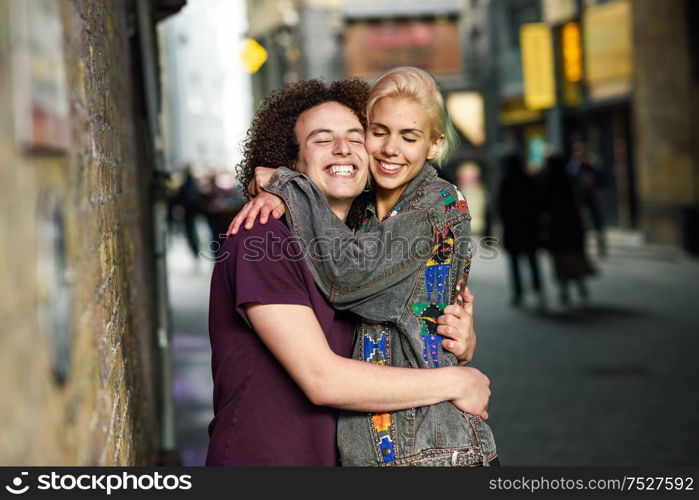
<box><xmin>0</xmin><ymin>0</ymin><xmax>158</xmax><ymax>465</ymax></box>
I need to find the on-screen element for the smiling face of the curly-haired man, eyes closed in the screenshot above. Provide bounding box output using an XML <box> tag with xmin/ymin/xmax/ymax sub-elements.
<box><xmin>294</xmin><ymin>101</ymin><xmax>369</xmax><ymax>206</ymax></box>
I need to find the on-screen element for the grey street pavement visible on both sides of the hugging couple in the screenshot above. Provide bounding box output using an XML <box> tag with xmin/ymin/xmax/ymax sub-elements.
<box><xmin>168</xmin><ymin>227</ymin><xmax>699</xmax><ymax>466</ymax></box>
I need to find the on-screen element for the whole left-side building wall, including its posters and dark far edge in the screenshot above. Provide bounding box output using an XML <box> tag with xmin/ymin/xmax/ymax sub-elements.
<box><xmin>0</xmin><ymin>0</ymin><xmax>184</xmax><ymax>465</ymax></box>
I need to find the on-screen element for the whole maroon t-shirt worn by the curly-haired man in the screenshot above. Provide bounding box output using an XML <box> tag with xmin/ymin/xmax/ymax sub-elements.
<box><xmin>206</xmin><ymin>219</ymin><xmax>352</xmax><ymax>466</ymax></box>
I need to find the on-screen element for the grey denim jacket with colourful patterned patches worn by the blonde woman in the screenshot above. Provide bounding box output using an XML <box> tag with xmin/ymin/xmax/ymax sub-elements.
<box><xmin>265</xmin><ymin>166</ymin><xmax>497</xmax><ymax>466</ymax></box>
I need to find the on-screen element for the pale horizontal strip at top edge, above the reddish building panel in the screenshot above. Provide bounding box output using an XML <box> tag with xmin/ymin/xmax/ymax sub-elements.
<box><xmin>343</xmin><ymin>0</ymin><xmax>461</xmax><ymax>19</ymax></box>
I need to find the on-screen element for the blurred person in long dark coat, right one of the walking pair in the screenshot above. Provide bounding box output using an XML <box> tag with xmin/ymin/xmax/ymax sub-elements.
<box><xmin>543</xmin><ymin>156</ymin><xmax>595</xmax><ymax>307</ymax></box>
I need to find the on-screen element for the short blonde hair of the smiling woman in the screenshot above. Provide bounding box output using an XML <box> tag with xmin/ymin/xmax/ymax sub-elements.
<box><xmin>366</xmin><ymin>66</ymin><xmax>457</xmax><ymax>166</ymax></box>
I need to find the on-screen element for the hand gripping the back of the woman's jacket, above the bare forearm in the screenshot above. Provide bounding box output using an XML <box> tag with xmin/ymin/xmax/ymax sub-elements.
<box><xmin>437</xmin><ymin>287</ymin><xmax>476</xmax><ymax>365</ymax></box>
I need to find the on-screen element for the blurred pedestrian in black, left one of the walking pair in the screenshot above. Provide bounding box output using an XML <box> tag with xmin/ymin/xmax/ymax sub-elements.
<box><xmin>497</xmin><ymin>154</ymin><xmax>546</xmax><ymax>309</ymax></box>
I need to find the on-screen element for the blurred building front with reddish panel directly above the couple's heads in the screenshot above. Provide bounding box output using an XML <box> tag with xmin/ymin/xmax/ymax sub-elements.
<box><xmin>248</xmin><ymin>0</ymin><xmax>466</xmax><ymax>94</ymax></box>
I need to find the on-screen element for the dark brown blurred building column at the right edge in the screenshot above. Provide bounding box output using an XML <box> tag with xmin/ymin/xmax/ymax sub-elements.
<box><xmin>632</xmin><ymin>0</ymin><xmax>699</xmax><ymax>248</ymax></box>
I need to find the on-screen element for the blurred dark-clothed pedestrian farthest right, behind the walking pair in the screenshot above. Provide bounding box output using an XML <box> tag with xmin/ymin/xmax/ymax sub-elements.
<box><xmin>566</xmin><ymin>142</ymin><xmax>607</xmax><ymax>257</ymax></box>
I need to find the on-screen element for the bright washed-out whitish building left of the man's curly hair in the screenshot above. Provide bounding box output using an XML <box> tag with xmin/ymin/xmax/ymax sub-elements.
<box><xmin>159</xmin><ymin>0</ymin><xmax>252</xmax><ymax>170</ymax></box>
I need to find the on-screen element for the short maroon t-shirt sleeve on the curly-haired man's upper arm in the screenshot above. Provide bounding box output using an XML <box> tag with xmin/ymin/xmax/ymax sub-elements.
<box><xmin>223</xmin><ymin>221</ymin><xmax>311</xmax><ymax>324</ymax></box>
